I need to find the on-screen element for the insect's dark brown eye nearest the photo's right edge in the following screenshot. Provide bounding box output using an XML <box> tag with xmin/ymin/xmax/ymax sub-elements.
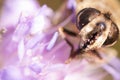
<box><xmin>103</xmin><ymin>23</ymin><xmax>119</xmax><ymax>46</ymax></box>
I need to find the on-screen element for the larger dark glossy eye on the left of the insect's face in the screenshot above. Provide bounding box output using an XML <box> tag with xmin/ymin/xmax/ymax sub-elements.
<box><xmin>76</xmin><ymin>8</ymin><xmax>101</xmax><ymax>30</ymax></box>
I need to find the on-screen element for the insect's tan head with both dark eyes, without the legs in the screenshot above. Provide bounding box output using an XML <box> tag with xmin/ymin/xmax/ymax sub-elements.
<box><xmin>76</xmin><ymin>8</ymin><xmax>119</xmax><ymax>49</ymax></box>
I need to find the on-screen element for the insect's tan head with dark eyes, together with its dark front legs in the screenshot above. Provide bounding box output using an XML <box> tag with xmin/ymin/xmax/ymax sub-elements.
<box><xmin>59</xmin><ymin>7</ymin><xmax>119</xmax><ymax>59</ymax></box>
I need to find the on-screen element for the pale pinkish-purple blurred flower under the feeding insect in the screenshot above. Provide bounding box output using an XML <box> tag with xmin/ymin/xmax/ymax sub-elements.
<box><xmin>0</xmin><ymin>0</ymin><xmax>120</xmax><ymax>80</ymax></box>
